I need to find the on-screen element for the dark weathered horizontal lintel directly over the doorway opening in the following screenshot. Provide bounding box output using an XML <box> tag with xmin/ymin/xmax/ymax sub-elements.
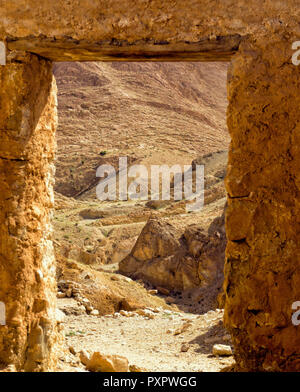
<box><xmin>6</xmin><ymin>34</ymin><xmax>243</xmax><ymax>61</ymax></box>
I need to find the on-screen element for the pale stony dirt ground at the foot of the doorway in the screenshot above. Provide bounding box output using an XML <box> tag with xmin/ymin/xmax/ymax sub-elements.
<box><xmin>58</xmin><ymin>298</ymin><xmax>233</xmax><ymax>372</ymax></box>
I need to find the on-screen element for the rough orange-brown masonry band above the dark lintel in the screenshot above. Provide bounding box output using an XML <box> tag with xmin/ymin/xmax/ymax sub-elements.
<box><xmin>0</xmin><ymin>0</ymin><xmax>300</xmax><ymax>43</ymax></box>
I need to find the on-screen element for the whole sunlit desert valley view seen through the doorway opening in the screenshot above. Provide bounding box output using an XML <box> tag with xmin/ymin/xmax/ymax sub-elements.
<box><xmin>53</xmin><ymin>62</ymin><xmax>234</xmax><ymax>372</ymax></box>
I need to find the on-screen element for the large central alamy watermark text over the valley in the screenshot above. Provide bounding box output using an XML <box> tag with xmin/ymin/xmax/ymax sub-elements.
<box><xmin>96</xmin><ymin>157</ymin><xmax>204</xmax><ymax>212</ymax></box>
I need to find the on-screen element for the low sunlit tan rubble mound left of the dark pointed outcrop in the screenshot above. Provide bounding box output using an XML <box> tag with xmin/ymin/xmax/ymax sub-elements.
<box><xmin>57</xmin><ymin>256</ymin><xmax>172</xmax><ymax>316</ymax></box>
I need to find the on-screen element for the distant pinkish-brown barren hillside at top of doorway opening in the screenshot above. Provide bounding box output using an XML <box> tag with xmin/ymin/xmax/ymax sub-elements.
<box><xmin>54</xmin><ymin>62</ymin><xmax>229</xmax><ymax>196</ymax></box>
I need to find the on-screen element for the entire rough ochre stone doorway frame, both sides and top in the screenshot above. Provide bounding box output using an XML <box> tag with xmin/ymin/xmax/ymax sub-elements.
<box><xmin>0</xmin><ymin>0</ymin><xmax>300</xmax><ymax>371</ymax></box>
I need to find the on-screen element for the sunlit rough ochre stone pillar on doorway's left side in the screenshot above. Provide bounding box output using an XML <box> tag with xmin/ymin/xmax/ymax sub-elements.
<box><xmin>0</xmin><ymin>55</ymin><xmax>58</xmax><ymax>371</ymax></box>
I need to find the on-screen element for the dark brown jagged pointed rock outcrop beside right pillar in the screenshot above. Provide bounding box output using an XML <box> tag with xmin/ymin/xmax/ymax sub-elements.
<box><xmin>119</xmin><ymin>213</ymin><xmax>226</xmax><ymax>291</ymax></box>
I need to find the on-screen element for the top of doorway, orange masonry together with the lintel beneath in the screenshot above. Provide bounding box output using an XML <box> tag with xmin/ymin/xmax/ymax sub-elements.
<box><xmin>0</xmin><ymin>0</ymin><xmax>300</xmax><ymax>61</ymax></box>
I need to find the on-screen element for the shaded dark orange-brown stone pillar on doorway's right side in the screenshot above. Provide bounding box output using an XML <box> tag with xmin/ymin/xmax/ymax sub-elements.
<box><xmin>224</xmin><ymin>35</ymin><xmax>300</xmax><ymax>371</ymax></box>
